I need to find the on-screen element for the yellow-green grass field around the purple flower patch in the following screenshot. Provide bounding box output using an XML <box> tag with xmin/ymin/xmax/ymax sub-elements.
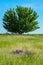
<box><xmin>0</xmin><ymin>34</ymin><xmax>43</xmax><ymax>65</ymax></box>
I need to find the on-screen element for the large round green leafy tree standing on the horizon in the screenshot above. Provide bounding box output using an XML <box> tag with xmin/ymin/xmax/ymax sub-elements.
<box><xmin>3</xmin><ymin>6</ymin><xmax>39</xmax><ymax>34</ymax></box>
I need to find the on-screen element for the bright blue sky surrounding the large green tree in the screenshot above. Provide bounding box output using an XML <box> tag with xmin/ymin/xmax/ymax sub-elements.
<box><xmin>0</xmin><ymin>0</ymin><xmax>43</xmax><ymax>34</ymax></box>
